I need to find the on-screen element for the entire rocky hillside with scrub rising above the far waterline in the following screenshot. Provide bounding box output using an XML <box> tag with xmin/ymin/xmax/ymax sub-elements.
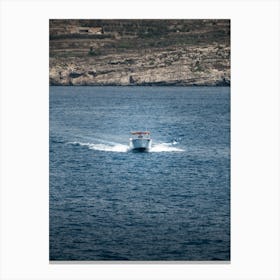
<box><xmin>49</xmin><ymin>20</ymin><xmax>230</xmax><ymax>85</ymax></box>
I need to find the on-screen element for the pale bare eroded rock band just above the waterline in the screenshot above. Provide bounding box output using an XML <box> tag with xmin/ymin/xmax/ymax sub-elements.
<box><xmin>50</xmin><ymin>45</ymin><xmax>230</xmax><ymax>85</ymax></box>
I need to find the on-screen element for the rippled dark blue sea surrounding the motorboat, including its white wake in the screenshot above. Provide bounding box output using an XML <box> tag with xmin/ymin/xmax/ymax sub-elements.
<box><xmin>49</xmin><ymin>86</ymin><xmax>230</xmax><ymax>261</ymax></box>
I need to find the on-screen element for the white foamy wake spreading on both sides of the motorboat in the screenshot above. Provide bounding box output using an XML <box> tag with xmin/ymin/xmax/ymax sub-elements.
<box><xmin>69</xmin><ymin>142</ymin><xmax>184</xmax><ymax>153</ymax></box>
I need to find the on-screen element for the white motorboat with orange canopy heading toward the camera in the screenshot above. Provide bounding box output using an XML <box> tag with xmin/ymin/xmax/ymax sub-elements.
<box><xmin>129</xmin><ymin>131</ymin><xmax>152</xmax><ymax>152</ymax></box>
